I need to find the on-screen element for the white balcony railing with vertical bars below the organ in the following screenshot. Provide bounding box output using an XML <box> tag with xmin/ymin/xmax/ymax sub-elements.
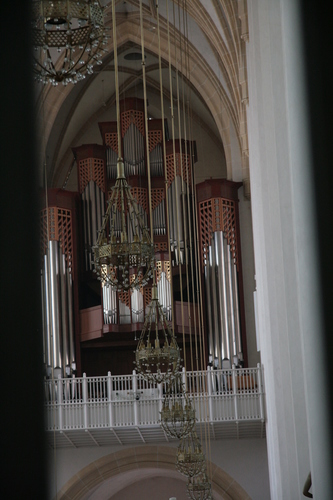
<box><xmin>45</xmin><ymin>365</ymin><xmax>265</xmax><ymax>446</ymax></box>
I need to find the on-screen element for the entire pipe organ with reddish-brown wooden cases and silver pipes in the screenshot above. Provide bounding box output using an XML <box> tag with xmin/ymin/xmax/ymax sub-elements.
<box><xmin>41</xmin><ymin>98</ymin><xmax>247</xmax><ymax>376</ymax></box>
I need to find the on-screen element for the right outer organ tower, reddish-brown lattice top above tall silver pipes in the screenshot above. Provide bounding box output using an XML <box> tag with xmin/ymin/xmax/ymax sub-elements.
<box><xmin>196</xmin><ymin>179</ymin><xmax>247</xmax><ymax>368</ymax></box>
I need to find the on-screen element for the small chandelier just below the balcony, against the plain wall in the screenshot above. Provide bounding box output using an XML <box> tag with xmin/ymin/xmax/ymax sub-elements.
<box><xmin>176</xmin><ymin>431</ymin><xmax>206</xmax><ymax>477</ymax></box>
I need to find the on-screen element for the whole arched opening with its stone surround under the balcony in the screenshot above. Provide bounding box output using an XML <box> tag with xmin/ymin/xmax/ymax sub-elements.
<box><xmin>58</xmin><ymin>446</ymin><xmax>249</xmax><ymax>500</ymax></box>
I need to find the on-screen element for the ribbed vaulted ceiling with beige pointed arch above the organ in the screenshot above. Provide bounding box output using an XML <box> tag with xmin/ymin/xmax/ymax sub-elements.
<box><xmin>36</xmin><ymin>0</ymin><xmax>249</xmax><ymax>189</ymax></box>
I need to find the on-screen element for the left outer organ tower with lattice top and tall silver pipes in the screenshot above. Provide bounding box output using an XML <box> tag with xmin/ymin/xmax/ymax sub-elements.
<box><xmin>41</xmin><ymin>189</ymin><xmax>80</xmax><ymax>378</ymax></box>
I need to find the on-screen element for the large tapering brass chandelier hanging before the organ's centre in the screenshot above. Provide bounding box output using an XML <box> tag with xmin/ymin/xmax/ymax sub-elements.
<box><xmin>92</xmin><ymin>158</ymin><xmax>155</xmax><ymax>291</ymax></box>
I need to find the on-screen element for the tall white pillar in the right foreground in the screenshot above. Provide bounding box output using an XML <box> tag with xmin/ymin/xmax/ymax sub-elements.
<box><xmin>247</xmin><ymin>0</ymin><xmax>332</xmax><ymax>500</ymax></box>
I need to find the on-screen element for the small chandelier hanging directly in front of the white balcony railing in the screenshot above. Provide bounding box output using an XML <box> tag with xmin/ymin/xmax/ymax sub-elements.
<box><xmin>161</xmin><ymin>374</ymin><xmax>196</xmax><ymax>439</ymax></box>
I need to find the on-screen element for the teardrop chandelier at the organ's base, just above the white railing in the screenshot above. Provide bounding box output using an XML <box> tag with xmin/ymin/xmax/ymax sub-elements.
<box><xmin>135</xmin><ymin>283</ymin><xmax>180</xmax><ymax>384</ymax></box>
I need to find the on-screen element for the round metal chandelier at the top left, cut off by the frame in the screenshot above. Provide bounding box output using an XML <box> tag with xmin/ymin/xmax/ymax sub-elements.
<box><xmin>32</xmin><ymin>0</ymin><xmax>107</xmax><ymax>85</ymax></box>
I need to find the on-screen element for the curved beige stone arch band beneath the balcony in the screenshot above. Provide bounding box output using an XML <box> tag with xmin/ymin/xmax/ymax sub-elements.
<box><xmin>57</xmin><ymin>446</ymin><xmax>250</xmax><ymax>500</ymax></box>
